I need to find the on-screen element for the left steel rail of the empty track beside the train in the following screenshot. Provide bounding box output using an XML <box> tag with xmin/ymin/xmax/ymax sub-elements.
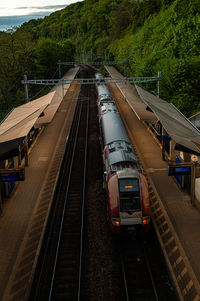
<box><xmin>48</xmin><ymin>102</ymin><xmax>82</xmax><ymax>301</ymax></box>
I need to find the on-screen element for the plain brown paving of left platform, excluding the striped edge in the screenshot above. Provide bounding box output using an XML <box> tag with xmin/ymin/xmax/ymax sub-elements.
<box><xmin>0</xmin><ymin>68</ymin><xmax>78</xmax><ymax>301</ymax></box>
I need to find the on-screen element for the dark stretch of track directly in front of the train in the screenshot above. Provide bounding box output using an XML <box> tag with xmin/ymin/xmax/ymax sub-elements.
<box><xmin>120</xmin><ymin>230</ymin><xmax>176</xmax><ymax>301</ymax></box>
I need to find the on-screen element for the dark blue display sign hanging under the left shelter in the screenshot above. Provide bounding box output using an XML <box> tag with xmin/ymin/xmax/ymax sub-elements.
<box><xmin>0</xmin><ymin>168</ymin><xmax>25</xmax><ymax>182</ymax></box>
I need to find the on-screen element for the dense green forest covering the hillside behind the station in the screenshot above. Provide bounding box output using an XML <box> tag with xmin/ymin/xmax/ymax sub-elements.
<box><xmin>0</xmin><ymin>0</ymin><xmax>200</xmax><ymax>119</ymax></box>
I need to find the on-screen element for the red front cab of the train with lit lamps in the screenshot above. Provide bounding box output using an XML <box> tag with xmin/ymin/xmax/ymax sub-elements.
<box><xmin>108</xmin><ymin>172</ymin><xmax>150</xmax><ymax>234</ymax></box>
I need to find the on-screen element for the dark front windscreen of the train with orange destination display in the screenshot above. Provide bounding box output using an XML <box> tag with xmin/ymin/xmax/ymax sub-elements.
<box><xmin>119</xmin><ymin>178</ymin><xmax>141</xmax><ymax>212</ymax></box>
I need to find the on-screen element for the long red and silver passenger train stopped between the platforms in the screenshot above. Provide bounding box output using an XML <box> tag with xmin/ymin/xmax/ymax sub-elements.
<box><xmin>95</xmin><ymin>73</ymin><xmax>150</xmax><ymax>234</ymax></box>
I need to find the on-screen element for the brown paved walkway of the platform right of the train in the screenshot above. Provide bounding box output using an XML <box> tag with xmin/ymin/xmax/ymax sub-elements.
<box><xmin>107</xmin><ymin>67</ymin><xmax>200</xmax><ymax>301</ymax></box>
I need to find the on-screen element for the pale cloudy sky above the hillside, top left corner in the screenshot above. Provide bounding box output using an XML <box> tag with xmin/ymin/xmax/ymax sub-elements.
<box><xmin>0</xmin><ymin>0</ymin><xmax>82</xmax><ymax>17</ymax></box>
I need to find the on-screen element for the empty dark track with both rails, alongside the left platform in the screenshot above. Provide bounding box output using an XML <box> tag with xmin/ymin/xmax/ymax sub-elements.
<box><xmin>30</xmin><ymin>73</ymin><xmax>89</xmax><ymax>300</ymax></box>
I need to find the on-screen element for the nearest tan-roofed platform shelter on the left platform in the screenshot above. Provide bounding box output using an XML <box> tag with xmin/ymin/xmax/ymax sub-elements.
<box><xmin>0</xmin><ymin>86</ymin><xmax>62</xmax><ymax>211</ymax></box>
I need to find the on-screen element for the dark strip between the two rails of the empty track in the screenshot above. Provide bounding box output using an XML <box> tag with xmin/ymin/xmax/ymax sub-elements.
<box><xmin>49</xmin><ymin>93</ymin><xmax>89</xmax><ymax>300</ymax></box>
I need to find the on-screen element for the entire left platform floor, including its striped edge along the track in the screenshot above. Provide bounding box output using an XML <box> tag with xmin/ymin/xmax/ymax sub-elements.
<box><xmin>0</xmin><ymin>67</ymin><xmax>80</xmax><ymax>301</ymax></box>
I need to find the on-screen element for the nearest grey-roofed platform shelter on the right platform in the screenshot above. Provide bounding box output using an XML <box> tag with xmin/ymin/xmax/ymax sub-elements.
<box><xmin>129</xmin><ymin>86</ymin><xmax>200</xmax><ymax>203</ymax></box>
